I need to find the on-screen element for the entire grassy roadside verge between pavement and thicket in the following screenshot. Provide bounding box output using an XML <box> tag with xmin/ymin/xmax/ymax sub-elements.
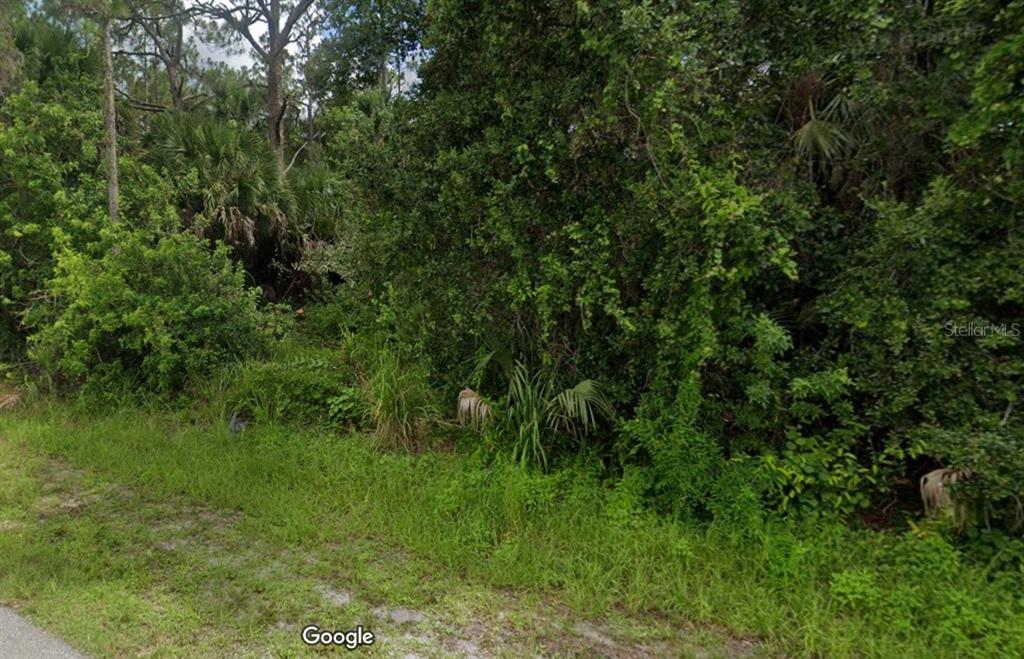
<box><xmin>0</xmin><ymin>405</ymin><xmax>1024</xmax><ymax>657</ymax></box>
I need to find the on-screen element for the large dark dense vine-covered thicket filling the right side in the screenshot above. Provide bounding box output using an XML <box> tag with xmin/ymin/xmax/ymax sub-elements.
<box><xmin>317</xmin><ymin>0</ymin><xmax>1024</xmax><ymax>514</ymax></box>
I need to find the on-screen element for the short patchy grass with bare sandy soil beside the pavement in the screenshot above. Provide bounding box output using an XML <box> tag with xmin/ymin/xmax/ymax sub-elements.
<box><xmin>0</xmin><ymin>421</ymin><xmax>764</xmax><ymax>657</ymax></box>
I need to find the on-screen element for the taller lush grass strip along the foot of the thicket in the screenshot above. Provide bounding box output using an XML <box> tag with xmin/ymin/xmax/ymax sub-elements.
<box><xmin>0</xmin><ymin>407</ymin><xmax>1024</xmax><ymax>657</ymax></box>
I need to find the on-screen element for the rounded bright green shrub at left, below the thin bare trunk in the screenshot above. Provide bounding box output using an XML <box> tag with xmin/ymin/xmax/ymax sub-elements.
<box><xmin>30</xmin><ymin>233</ymin><xmax>268</xmax><ymax>393</ymax></box>
